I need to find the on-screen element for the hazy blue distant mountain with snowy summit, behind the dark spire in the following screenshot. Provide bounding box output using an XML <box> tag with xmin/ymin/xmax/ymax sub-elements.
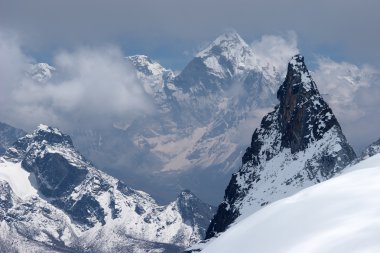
<box><xmin>67</xmin><ymin>32</ymin><xmax>280</xmax><ymax>203</ymax></box>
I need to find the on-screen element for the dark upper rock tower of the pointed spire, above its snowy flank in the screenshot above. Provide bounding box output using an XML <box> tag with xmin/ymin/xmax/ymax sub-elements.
<box><xmin>277</xmin><ymin>55</ymin><xmax>340</xmax><ymax>153</ymax></box>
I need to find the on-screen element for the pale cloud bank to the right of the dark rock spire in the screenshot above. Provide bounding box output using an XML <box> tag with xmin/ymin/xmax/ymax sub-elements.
<box><xmin>313</xmin><ymin>57</ymin><xmax>380</xmax><ymax>150</ymax></box>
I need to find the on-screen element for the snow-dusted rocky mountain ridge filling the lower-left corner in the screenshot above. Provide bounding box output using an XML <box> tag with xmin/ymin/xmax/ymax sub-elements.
<box><xmin>0</xmin><ymin>125</ymin><xmax>215</xmax><ymax>252</ymax></box>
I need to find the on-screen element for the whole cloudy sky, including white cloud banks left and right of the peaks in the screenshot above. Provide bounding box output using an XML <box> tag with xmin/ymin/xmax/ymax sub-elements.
<box><xmin>0</xmin><ymin>0</ymin><xmax>380</xmax><ymax>149</ymax></box>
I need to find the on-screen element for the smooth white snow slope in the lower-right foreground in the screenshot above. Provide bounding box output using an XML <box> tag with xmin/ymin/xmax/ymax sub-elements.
<box><xmin>202</xmin><ymin>154</ymin><xmax>380</xmax><ymax>253</ymax></box>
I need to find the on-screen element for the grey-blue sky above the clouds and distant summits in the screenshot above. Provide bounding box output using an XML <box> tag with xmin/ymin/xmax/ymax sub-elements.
<box><xmin>0</xmin><ymin>0</ymin><xmax>380</xmax><ymax>68</ymax></box>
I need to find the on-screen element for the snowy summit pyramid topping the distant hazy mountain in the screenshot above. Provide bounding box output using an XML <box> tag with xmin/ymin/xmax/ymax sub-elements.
<box><xmin>174</xmin><ymin>32</ymin><xmax>258</xmax><ymax>94</ymax></box>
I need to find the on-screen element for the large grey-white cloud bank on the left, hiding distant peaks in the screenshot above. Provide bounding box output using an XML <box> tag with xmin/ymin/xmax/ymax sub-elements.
<box><xmin>0</xmin><ymin>32</ymin><xmax>152</xmax><ymax>129</ymax></box>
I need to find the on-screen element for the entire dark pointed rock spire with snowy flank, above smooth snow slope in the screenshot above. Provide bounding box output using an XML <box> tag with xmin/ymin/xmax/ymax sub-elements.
<box><xmin>206</xmin><ymin>55</ymin><xmax>356</xmax><ymax>239</ymax></box>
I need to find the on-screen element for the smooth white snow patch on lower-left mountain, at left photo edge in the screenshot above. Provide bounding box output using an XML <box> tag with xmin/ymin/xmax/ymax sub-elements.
<box><xmin>0</xmin><ymin>157</ymin><xmax>37</xmax><ymax>199</ymax></box>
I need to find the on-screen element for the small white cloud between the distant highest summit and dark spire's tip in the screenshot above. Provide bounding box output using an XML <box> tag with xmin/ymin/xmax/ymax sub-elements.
<box><xmin>251</xmin><ymin>32</ymin><xmax>299</xmax><ymax>76</ymax></box>
